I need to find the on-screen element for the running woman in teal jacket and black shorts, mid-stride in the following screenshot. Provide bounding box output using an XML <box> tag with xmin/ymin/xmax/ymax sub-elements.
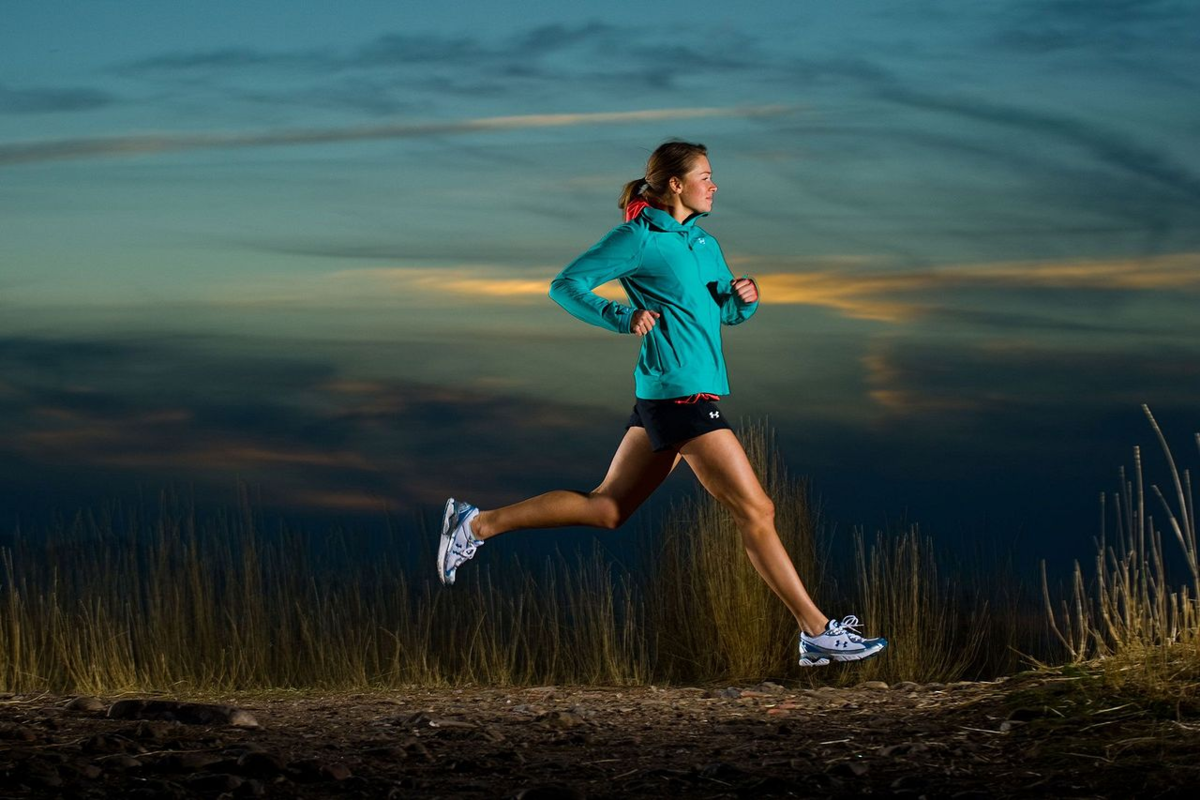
<box><xmin>437</xmin><ymin>142</ymin><xmax>888</xmax><ymax>667</ymax></box>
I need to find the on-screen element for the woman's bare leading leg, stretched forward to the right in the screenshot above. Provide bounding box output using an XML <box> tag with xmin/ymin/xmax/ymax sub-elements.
<box><xmin>679</xmin><ymin>431</ymin><xmax>829</xmax><ymax>636</ymax></box>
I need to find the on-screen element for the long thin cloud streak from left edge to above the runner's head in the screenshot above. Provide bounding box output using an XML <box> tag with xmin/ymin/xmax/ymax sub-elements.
<box><xmin>0</xmin><ymin>106</ymin><xmax>790</xmax><ymax>167</ymax></box>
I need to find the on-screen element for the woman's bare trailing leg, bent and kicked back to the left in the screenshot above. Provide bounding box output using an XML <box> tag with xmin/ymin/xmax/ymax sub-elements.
<box><xmin>472</xmin><ymin>427</ymin><xmax>679</xmax><ymax>540</ymax></box>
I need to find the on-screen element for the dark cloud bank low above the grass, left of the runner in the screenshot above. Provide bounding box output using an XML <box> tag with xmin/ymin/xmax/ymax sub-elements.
<box><xmin>0</xmin><ymin>337</ymin><xmax>611</xmax><ymax>513</ymax></box>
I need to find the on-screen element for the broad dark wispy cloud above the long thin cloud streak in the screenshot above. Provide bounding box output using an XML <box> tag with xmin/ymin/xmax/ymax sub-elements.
<box><xmin>113</xmin><ymin>22</ymin><xmax>769</xmax><ymax>114</ymax></box>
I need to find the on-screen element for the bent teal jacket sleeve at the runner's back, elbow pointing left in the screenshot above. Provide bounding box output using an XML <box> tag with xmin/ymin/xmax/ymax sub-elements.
<box><xmin>550</xmin><ymin>224</ymin><xmax>643</xmax><ymax>333</ymax></box>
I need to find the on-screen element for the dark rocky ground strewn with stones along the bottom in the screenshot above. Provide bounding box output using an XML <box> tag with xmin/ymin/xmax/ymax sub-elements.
<box><xmin>0</xmin><ymin>674</ymin><xmax>1200</xmax><ymax>800</ymax></box>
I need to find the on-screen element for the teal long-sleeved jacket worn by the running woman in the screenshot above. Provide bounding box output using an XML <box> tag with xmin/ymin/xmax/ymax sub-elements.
<box><xmin>550</xmin><ymin>209</ymin><xmax>758</xmax><ymax>399</ymax></box>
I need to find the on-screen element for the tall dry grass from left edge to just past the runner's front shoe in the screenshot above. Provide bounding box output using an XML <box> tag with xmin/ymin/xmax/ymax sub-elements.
<box><xmin>0</xmin><ymin>426</ymin><xmax>1032</xmax><ymax>693</ymax></box>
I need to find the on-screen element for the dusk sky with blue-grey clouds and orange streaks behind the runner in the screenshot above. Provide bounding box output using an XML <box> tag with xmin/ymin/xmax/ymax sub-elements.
<box><xmin>0</xmin><ymin>0</ymin><xmax>1200</xmax><ymax>575</ymax></box>
